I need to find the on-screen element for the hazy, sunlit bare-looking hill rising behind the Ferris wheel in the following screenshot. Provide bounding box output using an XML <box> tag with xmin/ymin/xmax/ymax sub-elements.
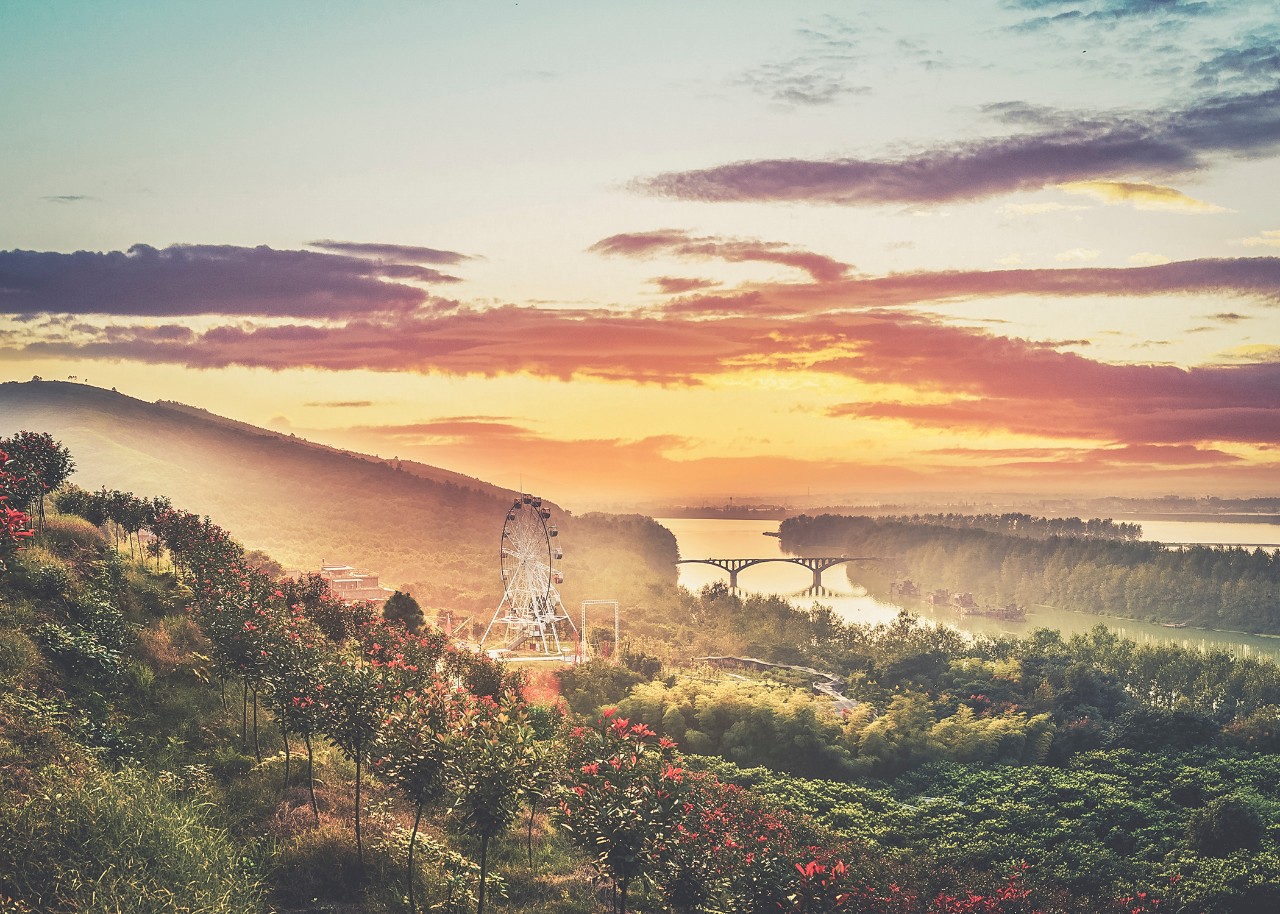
<box><xmin>0</xmin><ymin>381</ymin><xmax>676</xmax><ymax>614</ymax></box>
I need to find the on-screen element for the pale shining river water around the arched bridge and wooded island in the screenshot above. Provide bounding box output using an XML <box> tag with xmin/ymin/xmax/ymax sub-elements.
<box><xmin>657</xmin><ymin>517</ymin><xmax>1280</xmax><ymax>662</ymax></box>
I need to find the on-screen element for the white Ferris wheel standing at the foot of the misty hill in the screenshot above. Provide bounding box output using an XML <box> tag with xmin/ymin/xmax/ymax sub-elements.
<box><xmin>480</xmin><ymin>494</ymin><xmax>576</xmax><ymax>655</ymax></box>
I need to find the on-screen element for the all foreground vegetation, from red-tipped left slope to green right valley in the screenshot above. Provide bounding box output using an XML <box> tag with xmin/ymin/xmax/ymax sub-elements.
<box><xmin>0</xmin><ymin>434</ymin><xmax>1280</xmax><ymax>914</ymax></box>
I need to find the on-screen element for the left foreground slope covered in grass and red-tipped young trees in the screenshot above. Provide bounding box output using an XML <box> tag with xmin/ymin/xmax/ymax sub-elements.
<box><xmin>0</xmin><ymin>437</ymin><xmax>1187</xmax><ymax>914</ymax></box>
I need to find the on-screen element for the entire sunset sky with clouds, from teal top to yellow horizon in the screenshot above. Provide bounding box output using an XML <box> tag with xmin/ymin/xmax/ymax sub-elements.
<box><xmin>0</xmin><ymin>0</ymin><xmax>1280</xmax><ymax>507</ymax></box>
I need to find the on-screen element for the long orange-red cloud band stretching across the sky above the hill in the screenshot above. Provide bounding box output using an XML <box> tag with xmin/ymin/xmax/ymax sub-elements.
<box><xmin>19</xmin><ymin>300</ymin><xmax>1280</xmax><ymax>444</ymax></box>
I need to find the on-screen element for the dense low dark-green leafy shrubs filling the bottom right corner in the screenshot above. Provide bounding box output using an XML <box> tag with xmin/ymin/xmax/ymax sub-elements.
<box><xmin>687</xmin><ymin>750</ymin><xmax>1280</xmax><ymax>914</ymax></box>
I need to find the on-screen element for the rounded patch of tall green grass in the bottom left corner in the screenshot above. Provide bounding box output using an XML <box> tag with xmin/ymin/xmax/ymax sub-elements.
<box><xmin>0</xmin><ymin>769</ymin><xmax>264</xmax><ymax>914</ymax></box>
